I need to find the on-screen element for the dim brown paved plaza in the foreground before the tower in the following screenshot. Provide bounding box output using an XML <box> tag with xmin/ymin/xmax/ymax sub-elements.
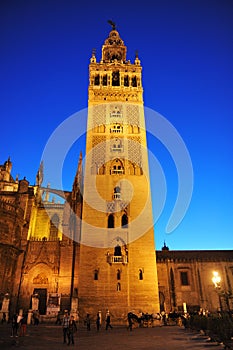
<box><xmin>0</xmin><ymin>324</ymin><xmax>224</xmax><ymax>350</ymax></box>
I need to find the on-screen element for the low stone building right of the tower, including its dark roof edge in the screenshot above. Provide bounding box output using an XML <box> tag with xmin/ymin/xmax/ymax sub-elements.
<box><xmin>157</xmin><ymin>246</ymin><xmax>233</xmax><ymax>311</ymax></box>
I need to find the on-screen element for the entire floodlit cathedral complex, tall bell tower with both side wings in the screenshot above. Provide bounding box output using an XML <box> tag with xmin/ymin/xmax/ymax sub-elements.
<box><xmin>0</xmin><ymin>22</ymin><xmax>233</xmax><ymax>323</ymax></box>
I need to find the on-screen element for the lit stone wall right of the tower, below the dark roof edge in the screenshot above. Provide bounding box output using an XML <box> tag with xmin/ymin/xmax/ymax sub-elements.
<box><xmin>157</xmin><ymin>252</ymin><xmax>233</xmax><ymax>312</ymax></box>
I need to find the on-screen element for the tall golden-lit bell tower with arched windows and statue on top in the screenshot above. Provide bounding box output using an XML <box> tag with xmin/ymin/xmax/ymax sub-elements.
<box><xmin>78</xmin><ymin>21</ymin><xmax>159</xmax><ymax>322</ymax></box>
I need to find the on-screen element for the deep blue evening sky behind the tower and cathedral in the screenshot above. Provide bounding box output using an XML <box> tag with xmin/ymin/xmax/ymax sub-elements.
<box><xmin>0</xmin><ymin>0</ymin><xmax>233</xmax><ymax>250</ymax></box>
